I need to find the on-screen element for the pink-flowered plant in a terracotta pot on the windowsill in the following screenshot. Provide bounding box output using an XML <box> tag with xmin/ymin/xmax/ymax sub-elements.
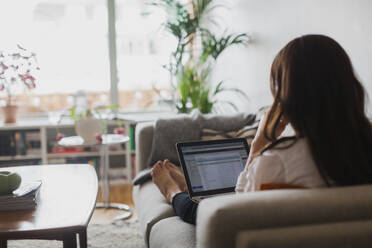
<box><xmin>0</xmin><ymin>45</ymin><xmax>39</xmax><ymax>123</ymax></box>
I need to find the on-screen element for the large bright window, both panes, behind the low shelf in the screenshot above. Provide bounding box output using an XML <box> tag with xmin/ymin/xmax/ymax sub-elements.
<box><xmin>0</xmin><ymin>0</ymin><xmax>172</xmax><ymax>113</ymax></box>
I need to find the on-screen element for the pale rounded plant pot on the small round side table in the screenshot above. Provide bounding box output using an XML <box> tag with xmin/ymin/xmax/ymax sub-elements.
<box><xmin>75</xmin><ymin>117</ymin><xmax>103</xmax><ymax>143</ymax></box>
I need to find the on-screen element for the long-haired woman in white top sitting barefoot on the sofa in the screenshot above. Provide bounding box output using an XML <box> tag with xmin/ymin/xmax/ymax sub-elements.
<box><xmin>152</xmin><ymin>35</ymin><xmax>372</xmax><ymax>224</ymax></box>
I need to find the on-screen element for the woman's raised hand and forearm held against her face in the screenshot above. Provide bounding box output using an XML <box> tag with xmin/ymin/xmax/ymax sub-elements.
<box><xmin>246</xmin><ymin>105</ymin><xmax>288</xmax><ymax>169</ymax></box>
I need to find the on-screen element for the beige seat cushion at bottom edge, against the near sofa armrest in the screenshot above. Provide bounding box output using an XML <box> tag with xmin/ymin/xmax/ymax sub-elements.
<box><xmin>150</xmin><ymin>216</ymin><xmax>196</xmax><ymax>248</ymax></box>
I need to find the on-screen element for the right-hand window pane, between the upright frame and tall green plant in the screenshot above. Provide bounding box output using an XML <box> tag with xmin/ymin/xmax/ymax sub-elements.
<box><xmin>116</xmin><ymin>0</ymin><xmax>176</xmax><ymax>110</ymax></box>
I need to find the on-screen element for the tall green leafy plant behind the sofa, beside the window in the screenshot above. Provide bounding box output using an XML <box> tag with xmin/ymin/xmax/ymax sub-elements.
<box><xmin>152</xmin><ymin>0</ymin><xmax>249</xmax><ymax>113</ymax></box>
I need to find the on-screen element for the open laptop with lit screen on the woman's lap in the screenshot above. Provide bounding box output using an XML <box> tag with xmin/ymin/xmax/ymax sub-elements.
<box><xmin>176</xmin><ymin>138</ymin><xmax>249</xmax><ymax>202</ymax></box>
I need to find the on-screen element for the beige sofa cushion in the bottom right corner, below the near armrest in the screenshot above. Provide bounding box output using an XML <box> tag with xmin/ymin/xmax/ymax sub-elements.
<box><xmin>236</xmin><ymin>220</ymin><xmax>372</xmax><ymax>248</ymax></box>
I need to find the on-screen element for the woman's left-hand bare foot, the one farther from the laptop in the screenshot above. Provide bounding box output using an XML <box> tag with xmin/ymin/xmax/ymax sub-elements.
<box><xmin>151</xmin><ymin>161</ymin><xmax>182</xmax><ymax>203</ymax></box>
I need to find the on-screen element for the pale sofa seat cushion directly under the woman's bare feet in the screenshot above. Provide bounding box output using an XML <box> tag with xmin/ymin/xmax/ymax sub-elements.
<box><xmin>133</xmin><ymin>181</ymin><xmax>174</xmax><ymax>244</ymax></box>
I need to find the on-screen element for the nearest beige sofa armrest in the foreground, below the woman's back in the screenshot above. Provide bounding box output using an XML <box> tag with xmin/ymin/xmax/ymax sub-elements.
<box><xmin>196</xmin><ymin>185</ymin><xmax>372</xmax><ymax>248</ymax></box>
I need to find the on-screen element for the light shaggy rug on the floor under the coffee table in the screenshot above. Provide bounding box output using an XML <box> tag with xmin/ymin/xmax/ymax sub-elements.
<box><xmin>8</xmin><ymin>220</ymin><xmax>146</xmax><ymax>248</ymax></box>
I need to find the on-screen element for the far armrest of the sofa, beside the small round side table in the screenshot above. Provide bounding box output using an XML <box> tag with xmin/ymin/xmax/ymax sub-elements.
<box><xmin>135</xmin><ymin>122</ymin><xmax>154</xmax><ymax>174</ymax></box>
